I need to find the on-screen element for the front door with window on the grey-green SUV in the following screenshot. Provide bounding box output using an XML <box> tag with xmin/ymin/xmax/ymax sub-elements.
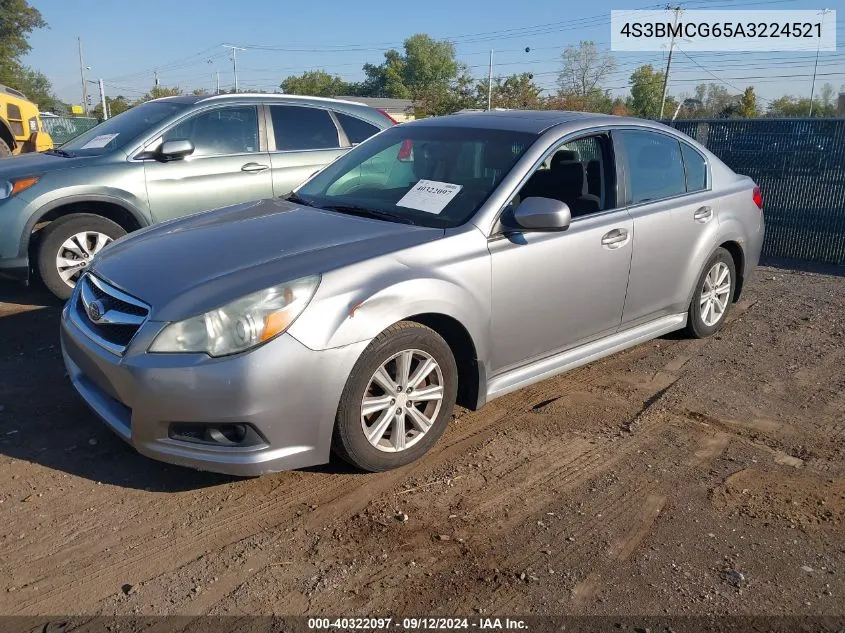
<box><xmin>144</xmin><ymin>105</ymin><xmax>273</xmax><ymax>222</ymax></box>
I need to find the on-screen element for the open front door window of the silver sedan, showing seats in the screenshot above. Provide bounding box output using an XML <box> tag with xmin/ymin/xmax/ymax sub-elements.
<box><xmin>516</xmin><ymin>134</ymin><xmax>615</xmax><ymax>218</ymax></box>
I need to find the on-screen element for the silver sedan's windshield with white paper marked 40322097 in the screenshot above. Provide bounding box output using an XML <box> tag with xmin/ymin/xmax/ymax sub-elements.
<box><xmin>295</xmin><ymin>125</ymin><xmax>537</xmax><ymax>227</ymax></box>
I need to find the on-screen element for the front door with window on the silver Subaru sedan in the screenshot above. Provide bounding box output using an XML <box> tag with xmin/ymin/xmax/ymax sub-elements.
<box><xmin>489</xmin><ymin>134</ymin><xmax>633</xmax><ymax>373</ymax></box>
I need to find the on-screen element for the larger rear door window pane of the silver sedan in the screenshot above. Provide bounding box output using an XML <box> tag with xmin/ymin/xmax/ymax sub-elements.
<box><xmin>618</xmin><ymin>130</ymin><xmax>687</xmax><ymax>204</ymax></box>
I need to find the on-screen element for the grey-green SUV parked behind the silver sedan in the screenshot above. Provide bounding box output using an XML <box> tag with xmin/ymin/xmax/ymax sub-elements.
<box><xmin>0</xmin><ymin>94</ymin><xmax>394</xmax><ymax>298</ymax></box>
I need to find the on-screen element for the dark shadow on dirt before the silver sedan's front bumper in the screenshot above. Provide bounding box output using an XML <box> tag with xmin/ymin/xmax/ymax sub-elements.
<box><xmin>0</xmin><ymin>281</ymin><xmax>357</xmax><ymax>492</ymax></box>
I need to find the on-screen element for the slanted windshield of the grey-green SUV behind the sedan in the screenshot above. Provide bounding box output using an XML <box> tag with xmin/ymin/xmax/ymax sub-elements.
<box><xmin>62</xmin><ymin>101</ymin><xmax>190</xmax><ymax>156</ymax></box>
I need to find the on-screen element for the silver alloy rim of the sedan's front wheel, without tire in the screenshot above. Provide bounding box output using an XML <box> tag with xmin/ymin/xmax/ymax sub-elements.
<box><xmin>361</xmin><ymin>349</ymin><xmax>444</xmax><ymax>453</ymax></box>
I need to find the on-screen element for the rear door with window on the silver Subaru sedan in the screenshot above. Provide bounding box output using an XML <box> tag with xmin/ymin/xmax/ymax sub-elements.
<box><xmin>613</xmin><ymin>128</ymin><xmax>719</xmax><ymax>327</ymax></box>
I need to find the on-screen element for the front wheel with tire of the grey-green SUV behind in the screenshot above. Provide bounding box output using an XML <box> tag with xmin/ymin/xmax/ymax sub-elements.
<box><xmin>37</xmin><ymin>213</ymin><xmax>126</xmax><ymax>299</ymax></box>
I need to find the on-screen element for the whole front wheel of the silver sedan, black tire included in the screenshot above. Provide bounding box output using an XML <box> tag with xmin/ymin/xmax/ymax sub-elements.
<box><xmin>332</xmin><ymin>321</ymin><xmax>458</xmax><ymax>472</ymax></box>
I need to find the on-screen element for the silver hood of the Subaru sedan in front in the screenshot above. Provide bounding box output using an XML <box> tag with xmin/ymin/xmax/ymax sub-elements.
<box><xmin>91</xmin><ymin>200</ymin><xmax>444</xmax><ymax>321</ymax></box>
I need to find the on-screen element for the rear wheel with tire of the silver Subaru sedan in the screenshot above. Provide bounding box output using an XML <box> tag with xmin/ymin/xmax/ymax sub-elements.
<box><xmin>687</xmin><ymin>247</ymin><xmax>736</xmax><ymax>338</ymax></box>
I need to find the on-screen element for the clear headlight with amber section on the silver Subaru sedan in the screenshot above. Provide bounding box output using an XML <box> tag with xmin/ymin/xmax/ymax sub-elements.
<box><xmin>150</xmin><ymin>275</ymin><xmax>320</xmax><ymax>356</ymax></box>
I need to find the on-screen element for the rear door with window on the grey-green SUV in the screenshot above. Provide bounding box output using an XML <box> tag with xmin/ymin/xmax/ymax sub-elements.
<box><xmin>266</xmin><ymin>104</ymin><xmax>350</xmax><ymax>197</ymax></box>
